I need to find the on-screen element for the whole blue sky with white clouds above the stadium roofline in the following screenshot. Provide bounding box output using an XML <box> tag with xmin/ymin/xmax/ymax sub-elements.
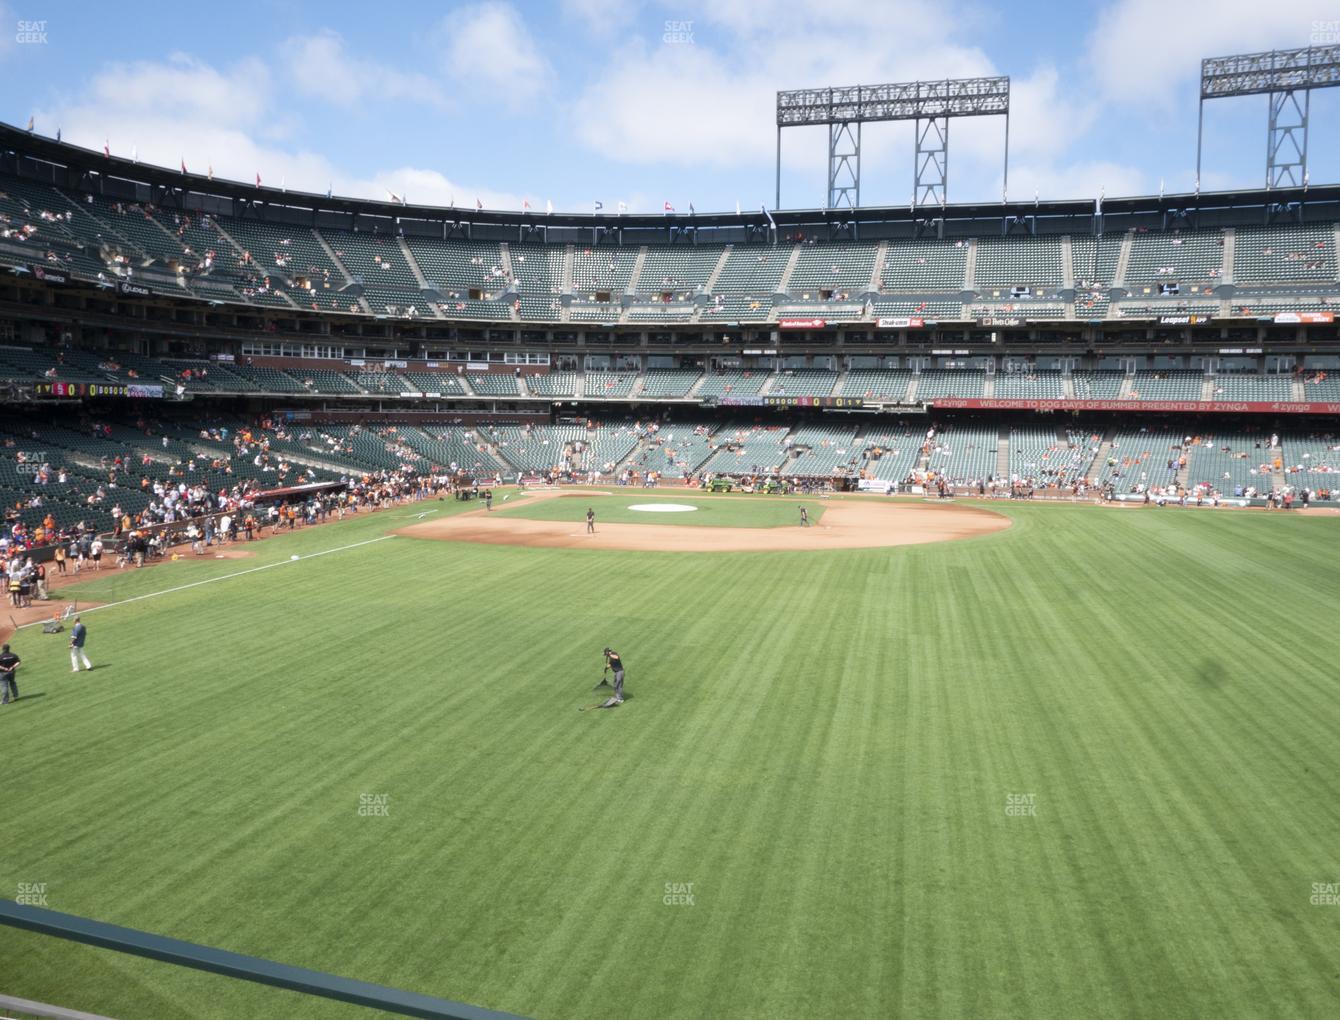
<box><xmin>0</xmin><ymin>0</ymin><xmax>1340</xmax><ymax>212</ymax></box>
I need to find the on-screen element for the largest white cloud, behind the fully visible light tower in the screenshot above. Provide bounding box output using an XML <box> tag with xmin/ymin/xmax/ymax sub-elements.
<box><xmin>572</xmin><ymin>0</ymin><xmax>1139</xmax><ymax>205</ymax></box>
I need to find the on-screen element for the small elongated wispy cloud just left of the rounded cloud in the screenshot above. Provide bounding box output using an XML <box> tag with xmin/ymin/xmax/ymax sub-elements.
<box><xmin>280</xmin><ymin>29</ymin><xmax>446</xmax><ymax>106</ymax></box>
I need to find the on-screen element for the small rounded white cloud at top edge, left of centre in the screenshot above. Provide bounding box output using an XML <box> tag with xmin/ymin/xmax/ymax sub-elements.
<box><xmin>436</xmin><ymin>0</ymin><xmax>549</xmax><ymax>106</ymax></box>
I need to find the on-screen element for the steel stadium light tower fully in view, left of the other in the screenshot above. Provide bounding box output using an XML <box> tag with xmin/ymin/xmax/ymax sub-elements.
<box><xmin>773</xmin><ymin>78</ymin><xmax>1009</xmax><ymax>209</ymax></box>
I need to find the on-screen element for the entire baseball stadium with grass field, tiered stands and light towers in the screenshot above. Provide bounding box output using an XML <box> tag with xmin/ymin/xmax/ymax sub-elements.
<box><xmin>0</xmin><ymin>4</ymin><xmax>1340</xmax><ymax>1020</ymax></box>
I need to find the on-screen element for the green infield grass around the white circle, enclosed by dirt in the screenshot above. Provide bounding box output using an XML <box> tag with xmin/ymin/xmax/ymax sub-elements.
<box><xmin>493</xmin><ymin>488</ymin><xmax>824</xmax><ymax>528</ymax></box>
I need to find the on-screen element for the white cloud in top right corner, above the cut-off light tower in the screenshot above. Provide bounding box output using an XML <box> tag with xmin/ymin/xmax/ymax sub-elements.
<box><xmin>1088</xmin><ymin>0</ymin><xmax>1340</xmax><ymax>107</ymax></box>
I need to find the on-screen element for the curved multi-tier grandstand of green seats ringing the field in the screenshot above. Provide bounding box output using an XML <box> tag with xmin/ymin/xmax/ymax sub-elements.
<box><xmin>0</xmin><ymin>121</ymin><xmax>1340</xmax><ymax>533</ymax></box>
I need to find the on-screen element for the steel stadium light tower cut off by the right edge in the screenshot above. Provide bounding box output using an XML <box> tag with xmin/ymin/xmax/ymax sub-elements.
<box><xmin>1195</xmin><ymin>46</ymin><xmax>1340</xmax><ymax>192</ymax></box>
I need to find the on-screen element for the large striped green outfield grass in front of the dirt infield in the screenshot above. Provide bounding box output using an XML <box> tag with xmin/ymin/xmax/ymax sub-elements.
<box><xmin>0</xmin><ymin>501</ymin><xmax>1340</xmax><ymax>1020</ymax></box>
